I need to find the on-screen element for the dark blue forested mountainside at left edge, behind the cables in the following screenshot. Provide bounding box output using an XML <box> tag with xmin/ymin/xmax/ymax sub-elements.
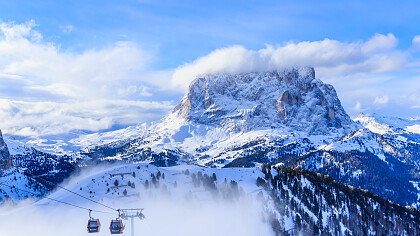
<box><xmin>0</xmin><ymin>131</ymin><xmax>75</xmax><ymax>202</ymax></box>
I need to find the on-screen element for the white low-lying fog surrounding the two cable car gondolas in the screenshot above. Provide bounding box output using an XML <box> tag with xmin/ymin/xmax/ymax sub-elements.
<box><xmin>0</xmin><ymin>164</ymin><xmax>273</xmax><ymax>236</ymax></box>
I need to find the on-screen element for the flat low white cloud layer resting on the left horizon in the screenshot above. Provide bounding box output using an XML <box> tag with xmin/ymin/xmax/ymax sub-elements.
<box><xmin>0</xmin><ymin>99</ymin><xmax>174</xmax><ymax>137</ymax></box>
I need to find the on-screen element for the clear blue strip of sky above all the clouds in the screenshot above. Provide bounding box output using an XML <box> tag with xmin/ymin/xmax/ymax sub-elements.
<box><xmin>0</xmin><ymin>0</ymin><xmax>420</xmax><ymax>66</ymax></box>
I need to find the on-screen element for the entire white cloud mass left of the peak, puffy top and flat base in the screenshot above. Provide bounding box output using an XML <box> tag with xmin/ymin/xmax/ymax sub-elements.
<box><xmin>0</xmin><ymin>21</ymin><xmax>173</xmax><ymax>136</ymax></box>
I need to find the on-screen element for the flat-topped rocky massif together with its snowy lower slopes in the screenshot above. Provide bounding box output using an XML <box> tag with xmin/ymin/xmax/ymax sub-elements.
<box><xmin>79</xmin><ymin>67</ymin><xmax>361</xmax><ymax>167</ymax></box>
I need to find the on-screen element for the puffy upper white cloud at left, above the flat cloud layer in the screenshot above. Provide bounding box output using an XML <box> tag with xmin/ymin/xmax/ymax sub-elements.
<box><xmin>0</xmin><ymin>21</ymin><xmax>158</xmax><ymax>98</ymax></box>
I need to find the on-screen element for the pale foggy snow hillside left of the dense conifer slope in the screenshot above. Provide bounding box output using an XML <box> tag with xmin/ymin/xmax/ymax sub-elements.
<box><xmin>4</xmin><ymin>163</ymin><xmax>274</xmax><ymax>236</ymax></box>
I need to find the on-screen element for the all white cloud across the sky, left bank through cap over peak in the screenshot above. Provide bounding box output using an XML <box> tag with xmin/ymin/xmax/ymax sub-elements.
<box><xmin>0</xmin><ymin>20</ymin><xmax>420</xmax><ymax>139</ymax></box>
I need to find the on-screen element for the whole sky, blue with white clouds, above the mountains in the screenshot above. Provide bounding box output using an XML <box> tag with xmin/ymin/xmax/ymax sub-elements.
<box><xmin>0</xmin><ymin>0</ymin><xmax>420</xmax><ymax>135</ymax></box>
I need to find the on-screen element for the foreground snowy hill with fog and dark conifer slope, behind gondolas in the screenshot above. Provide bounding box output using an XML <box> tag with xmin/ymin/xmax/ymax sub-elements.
<box><xmin>4</xmin><ymin>163</ymin><xmax>420</xmax><ymax>236</ymax></box>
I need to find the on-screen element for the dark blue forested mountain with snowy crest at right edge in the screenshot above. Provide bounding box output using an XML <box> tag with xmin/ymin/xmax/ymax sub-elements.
<box><xmin>299</xmin><ymin>114</ymin><xmax>420</xmax><ymax>207</ymax></box>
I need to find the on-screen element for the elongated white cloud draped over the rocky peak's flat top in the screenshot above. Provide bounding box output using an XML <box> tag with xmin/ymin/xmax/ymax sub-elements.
<box><xmin>172</xmin><ymin>34</ymin><xmax>406</xmax><ymax>89</ymax></box>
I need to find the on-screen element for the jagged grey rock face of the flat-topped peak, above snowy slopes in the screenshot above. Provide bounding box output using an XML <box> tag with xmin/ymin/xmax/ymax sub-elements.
<box><xmin>173</xmin><ymin>67</ymin><xmax>354</xmax><ymax>134</ymax></box>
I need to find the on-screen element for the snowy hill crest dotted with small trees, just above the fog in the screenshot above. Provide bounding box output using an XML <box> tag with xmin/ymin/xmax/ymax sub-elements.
<box><xmin>38</xmin><ymin>163</ymin><xmax>264</xmax><ymax>205</ymax></box>
